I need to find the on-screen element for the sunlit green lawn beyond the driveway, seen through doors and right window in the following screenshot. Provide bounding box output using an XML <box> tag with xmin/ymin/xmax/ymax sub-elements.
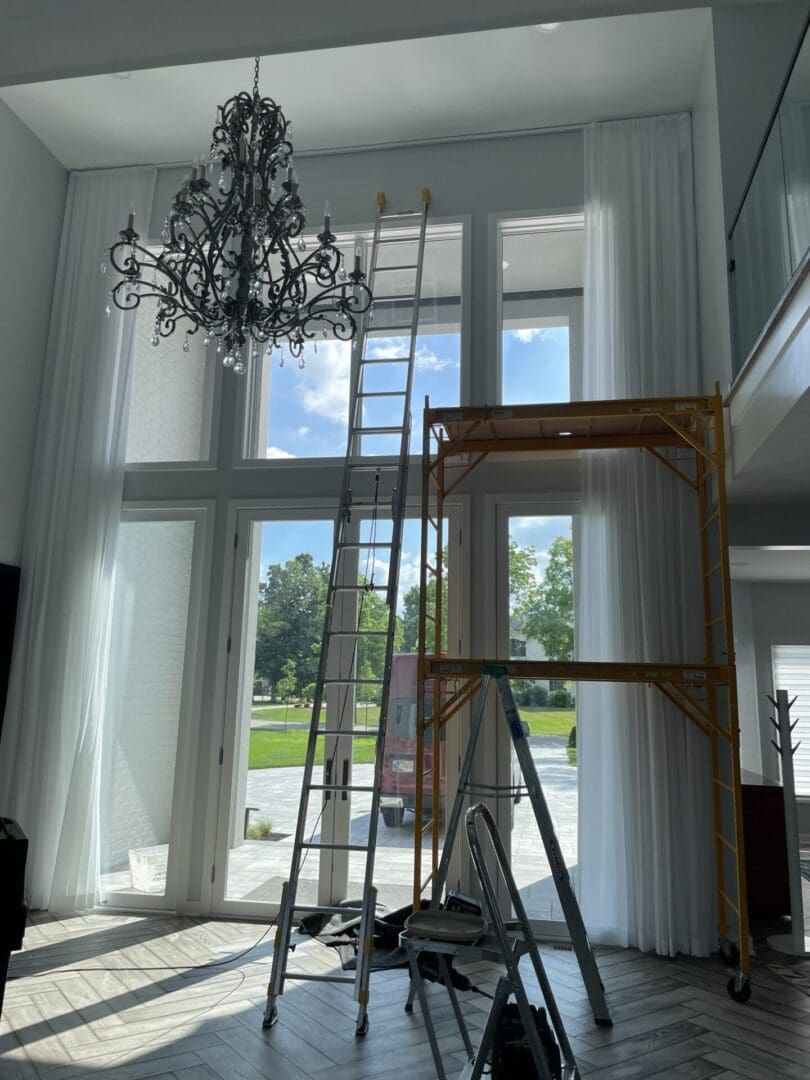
<box><xmin>247</xmin><ymin>705</ymin><xmax>576</xmax><ymax>769</ymax></box>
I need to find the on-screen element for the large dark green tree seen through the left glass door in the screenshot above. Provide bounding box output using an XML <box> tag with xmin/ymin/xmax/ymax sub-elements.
<box><xmin>255</xmin><ymin>552</ymin><xmax>329</xmax><ymax>693</ymax></box>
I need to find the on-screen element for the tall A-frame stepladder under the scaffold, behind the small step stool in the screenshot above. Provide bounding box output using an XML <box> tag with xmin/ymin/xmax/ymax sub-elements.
<box><xmin>430</xmin><ymin>664</ymin><xmax>612</xmax><ymax>1026</ymax></box>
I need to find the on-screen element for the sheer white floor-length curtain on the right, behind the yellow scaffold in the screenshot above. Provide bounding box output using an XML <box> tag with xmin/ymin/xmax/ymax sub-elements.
<box><xmin>577</xmin><ymin>116</ymin><xmax>715</xmax><ymax>955</ymax></box>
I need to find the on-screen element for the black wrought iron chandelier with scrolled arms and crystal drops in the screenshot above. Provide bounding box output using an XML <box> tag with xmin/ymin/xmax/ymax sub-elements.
<box><xmin>108</xmin><ymin>56</ymin><xmax>372</xmax><ymax>374</ymax></box>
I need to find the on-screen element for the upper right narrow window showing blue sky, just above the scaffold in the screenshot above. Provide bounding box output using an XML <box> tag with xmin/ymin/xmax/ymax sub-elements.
<box><xmin>500</xmin><ymin>215</ymin><xmax>582</xmax><ymax>405</ymax></box>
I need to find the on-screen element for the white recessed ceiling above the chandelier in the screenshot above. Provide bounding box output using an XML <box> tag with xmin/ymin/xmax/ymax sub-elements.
<box><xmin>0</xmin><ymin>10</ymin><xmax>710</xmax><ymax>168</ymax></box>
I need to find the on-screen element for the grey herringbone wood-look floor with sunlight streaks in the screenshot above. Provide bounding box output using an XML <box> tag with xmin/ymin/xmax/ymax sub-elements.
<box><xmin>0</xmin><ymin>915</ymin><xmax>810</xmax><ymax>1080</ymax></box>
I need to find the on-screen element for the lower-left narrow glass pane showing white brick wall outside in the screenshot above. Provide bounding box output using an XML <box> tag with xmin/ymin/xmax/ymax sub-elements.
<box><xmin>100</xmin><ymin>521</ymin><xmax>194</xmax><ymax>895</ymax></box>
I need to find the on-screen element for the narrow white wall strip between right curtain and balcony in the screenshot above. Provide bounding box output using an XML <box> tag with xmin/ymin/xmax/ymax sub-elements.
<box><xmin>692</xmin><ymin>17</ymin><xmax>731</xmax><ymax>391</ymax></box>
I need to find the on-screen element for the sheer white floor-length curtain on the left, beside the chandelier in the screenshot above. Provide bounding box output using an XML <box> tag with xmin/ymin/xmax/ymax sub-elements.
<box><xmin>0</xmin><ymin>168</ymin><xmax>156</xmax><ymax>912</ymax></box>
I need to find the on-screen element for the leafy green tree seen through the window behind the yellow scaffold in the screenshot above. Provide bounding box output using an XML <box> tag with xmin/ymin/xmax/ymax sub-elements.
<box><xmin>514</xmin><ymin>536</ymin><xmax>573</xmax><ymax>660</ymax></box>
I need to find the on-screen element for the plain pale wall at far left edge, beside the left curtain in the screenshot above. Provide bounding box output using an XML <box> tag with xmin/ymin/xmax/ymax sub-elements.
<box><xmin>0</xmin><ymin>102</ymin><xmax>67</xmax><ymax>565</ymax></box>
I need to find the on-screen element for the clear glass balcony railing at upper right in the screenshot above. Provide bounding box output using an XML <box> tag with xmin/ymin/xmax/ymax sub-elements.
<box><xmin>729</xmin><ymin>19</ymin><xmax>810</xmax><ymax>375</ymax></box>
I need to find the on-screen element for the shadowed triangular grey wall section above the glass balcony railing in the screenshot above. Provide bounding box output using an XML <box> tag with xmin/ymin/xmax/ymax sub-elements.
<box><xmin>713</xmin><ymin>0</ymin><xmax>808</xmax><ymax>228</ymax></box>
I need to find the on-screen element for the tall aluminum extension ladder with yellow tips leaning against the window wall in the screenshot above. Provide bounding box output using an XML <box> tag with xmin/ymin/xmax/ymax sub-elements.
<box><xmin>264</xmin><ymin>188</ymin><xmax>430</xmax><ymax>1036</ymax></box>
